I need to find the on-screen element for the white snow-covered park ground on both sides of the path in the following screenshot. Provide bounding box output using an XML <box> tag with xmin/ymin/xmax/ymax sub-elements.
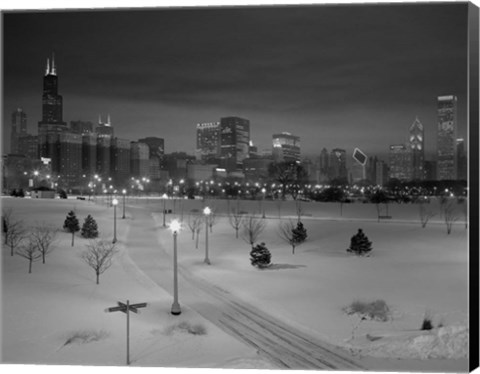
<box><xmin>2</xmin><ymin>198</ymin><xmax>468</xmax><ymax>372</ymax></box>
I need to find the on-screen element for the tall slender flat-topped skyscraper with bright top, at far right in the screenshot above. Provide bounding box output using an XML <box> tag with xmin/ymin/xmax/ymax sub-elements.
<box><xmin>437</xmin><ymin>95</ymin><xmax>457</xmax><ymax>180</ymax></box>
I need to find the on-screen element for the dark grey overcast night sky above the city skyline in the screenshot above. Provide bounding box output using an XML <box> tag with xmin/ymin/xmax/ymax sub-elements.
<box><xmin>3</xmin><ymin>3</ymin><xmax>467</xmax><ymax>159</ymax></box>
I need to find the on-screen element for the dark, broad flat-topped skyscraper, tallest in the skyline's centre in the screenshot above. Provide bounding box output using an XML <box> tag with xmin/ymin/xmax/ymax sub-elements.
<box><xmin>220</xmin><ymin>117</ymin><xmax>250</xmax><ymax>172</ymax></box>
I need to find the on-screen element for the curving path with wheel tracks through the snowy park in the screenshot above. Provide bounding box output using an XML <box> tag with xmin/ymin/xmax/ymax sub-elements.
<box><xmin>126</xmin><ymin>207</ymin><xmax>362</xmax><ymax>370</ymax></box>
